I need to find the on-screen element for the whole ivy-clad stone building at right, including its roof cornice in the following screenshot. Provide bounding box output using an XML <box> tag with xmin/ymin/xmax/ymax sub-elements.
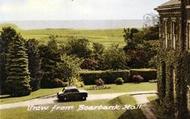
<box><xmin>156</xmin><ymin>0</ymin><xmax>190</xmax><ymax>119</ymax></box>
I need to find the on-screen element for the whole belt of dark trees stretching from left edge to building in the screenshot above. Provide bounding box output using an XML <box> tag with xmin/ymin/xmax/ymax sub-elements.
<box><xmin>0</xmin><ymin>27</ymin><xmax>157</xmax><ymax>96</ymax></box>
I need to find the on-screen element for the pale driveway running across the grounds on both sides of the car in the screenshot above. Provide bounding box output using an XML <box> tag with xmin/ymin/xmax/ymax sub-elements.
<box><xmin>0</xmin><ymin>91</ymin><xmax>156</xmax><ymax>110</ymax></box>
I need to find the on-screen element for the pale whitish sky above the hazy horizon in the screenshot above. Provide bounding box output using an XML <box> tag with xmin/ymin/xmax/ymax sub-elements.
<box><xmin>0</xmin><ymin>0</ymin><xmax>168</xmax><ymax>21</ymax></box>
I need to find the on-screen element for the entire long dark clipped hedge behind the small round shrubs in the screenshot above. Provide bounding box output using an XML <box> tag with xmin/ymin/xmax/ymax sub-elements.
<box><xmin>80</xmin><ymin>69</ymin><xmax>157</xmax><ymax>85</ymax></box>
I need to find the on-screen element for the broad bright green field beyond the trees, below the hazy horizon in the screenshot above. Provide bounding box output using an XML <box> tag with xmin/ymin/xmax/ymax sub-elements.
<box><xmin>0</xmin><ymin>25</ymin><xmax>125</xmax><ymax>47</ymax></box>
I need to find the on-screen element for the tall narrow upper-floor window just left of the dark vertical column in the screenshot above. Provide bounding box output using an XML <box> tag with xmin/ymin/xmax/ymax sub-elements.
<box><xmin>171</xmin><ymin>21</ymin><xmax>177</xmax><ymax>49</ymax></box>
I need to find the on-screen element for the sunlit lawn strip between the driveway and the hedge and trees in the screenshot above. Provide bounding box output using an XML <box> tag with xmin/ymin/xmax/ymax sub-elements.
<box><xmin>0</xmin><ymin>82</ymin><xmax>157</xmax><ymax>104</ymax></box>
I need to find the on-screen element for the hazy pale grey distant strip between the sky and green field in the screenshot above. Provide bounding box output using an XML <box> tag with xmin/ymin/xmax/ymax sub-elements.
<box><xmin>0</xmin><ymin>20</ymin><xmax>143</xmax><ymax>29</ymax></box>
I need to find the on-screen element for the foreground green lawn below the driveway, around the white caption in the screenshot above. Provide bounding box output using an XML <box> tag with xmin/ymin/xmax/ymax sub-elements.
<box><xmin>0</xmin><ymin>95</ymin><xmax>145</xmax><ymax>119</ymax></box>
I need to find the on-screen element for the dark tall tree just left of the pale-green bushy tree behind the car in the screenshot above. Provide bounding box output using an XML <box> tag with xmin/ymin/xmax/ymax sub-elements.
<box><xmin>39</xmin><ymin>38</ymin><xmax>61</xmax><ymax>88</ymax></box>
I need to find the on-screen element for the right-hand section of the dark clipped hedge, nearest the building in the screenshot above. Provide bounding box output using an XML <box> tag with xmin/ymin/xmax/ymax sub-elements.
<box><xmin>130</xmin><ymin>69</ymin><xmax>157</xmax><ymax>81</ymax></box>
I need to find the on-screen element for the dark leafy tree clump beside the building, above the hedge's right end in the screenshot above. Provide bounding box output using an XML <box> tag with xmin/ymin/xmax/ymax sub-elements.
<box><xmin>123</xmin><ymin>26</ymin><xmax>159</xmax><ymax>68</ymax></box>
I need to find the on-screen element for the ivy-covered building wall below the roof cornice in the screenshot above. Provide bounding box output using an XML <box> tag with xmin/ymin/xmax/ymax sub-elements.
<box><xmin>158</xmin><ymin>6</ymin><xmax>190</xmax><ymax>118</ymax></box>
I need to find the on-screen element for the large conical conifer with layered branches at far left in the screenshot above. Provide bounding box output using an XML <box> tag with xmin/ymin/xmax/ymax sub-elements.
<box><xmin>5</xmin><ymin>34</ymin><xmax>31</xmax><ymax>96</ymax></box>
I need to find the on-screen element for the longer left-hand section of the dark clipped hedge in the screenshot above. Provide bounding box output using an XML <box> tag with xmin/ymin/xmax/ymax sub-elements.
<box><xmin>80</xmin><ymin>70</ymin><xmax>129</xmax><ymax>85</ymax></box>
